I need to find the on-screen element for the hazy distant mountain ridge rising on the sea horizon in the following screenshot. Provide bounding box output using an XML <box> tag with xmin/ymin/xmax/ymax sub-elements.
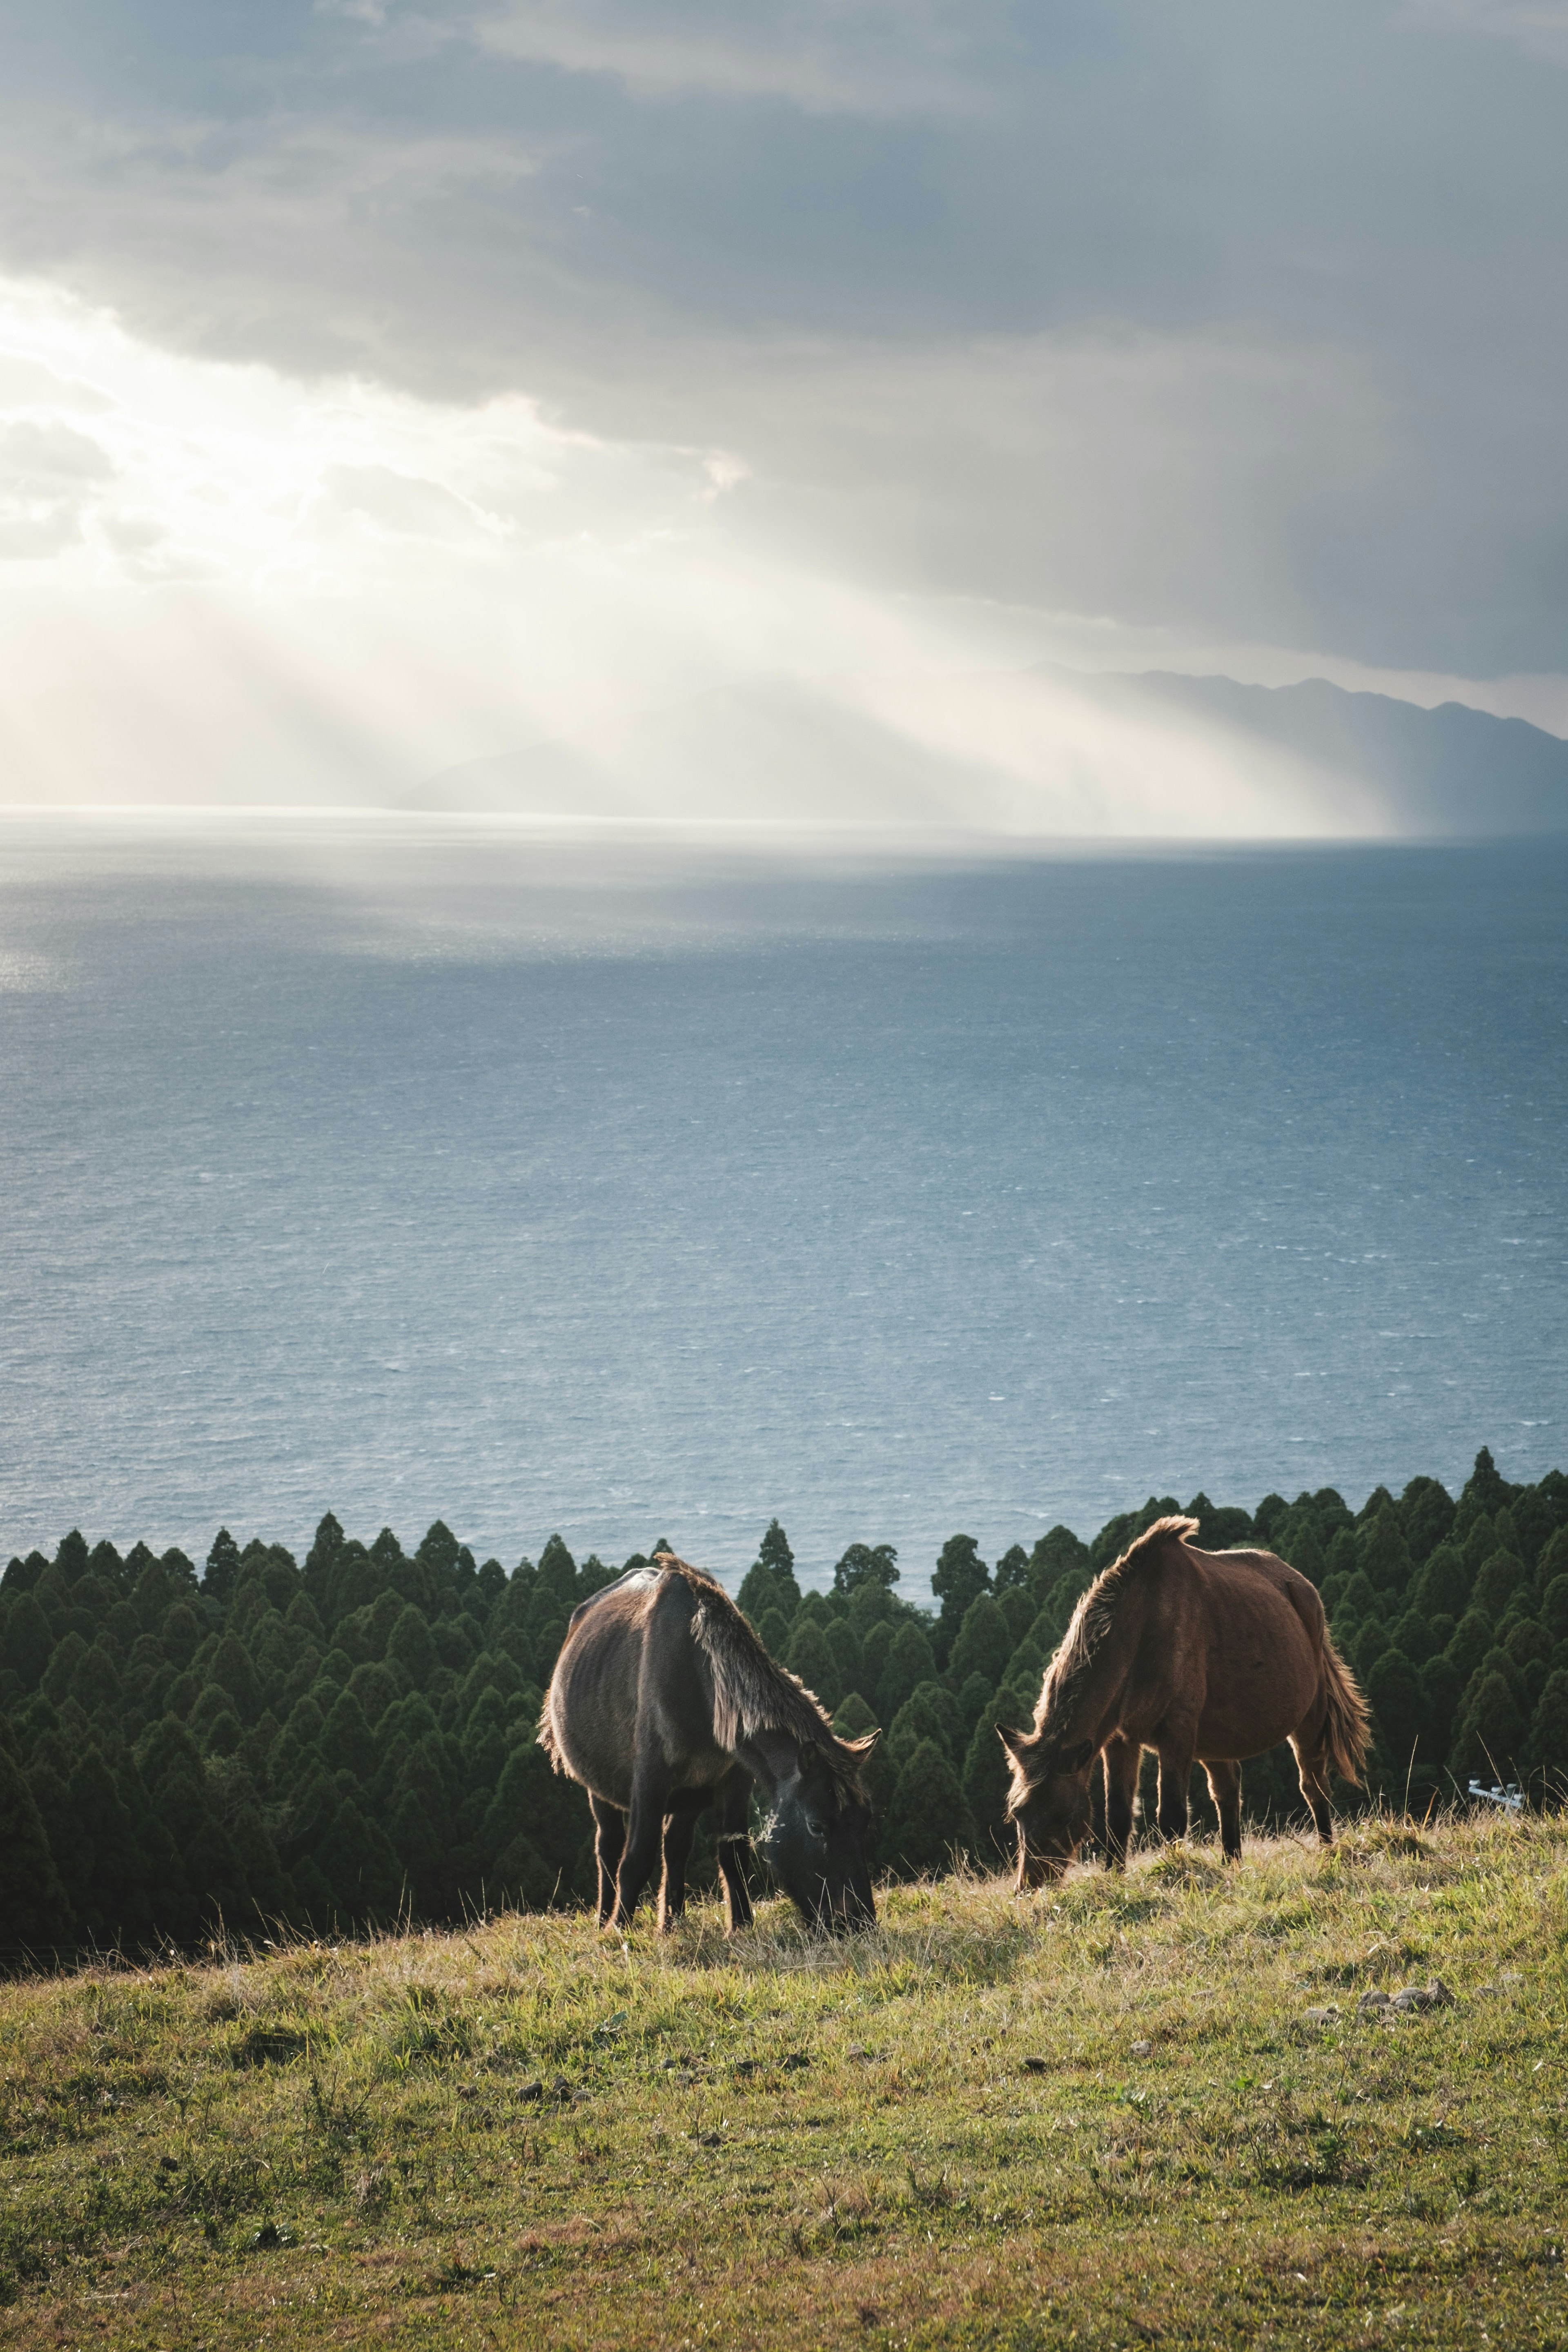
<box><xmin>400</xmin><ymin>663</ymin><xmax>1568</xmax><ymax>840</ymax></box>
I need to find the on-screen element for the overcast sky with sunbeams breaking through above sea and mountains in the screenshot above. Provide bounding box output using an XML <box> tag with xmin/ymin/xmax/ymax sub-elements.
<box><xmin>0</xmin><ymin>0</ymin><xmax>1568</xmax><ymax>800</ymax></box>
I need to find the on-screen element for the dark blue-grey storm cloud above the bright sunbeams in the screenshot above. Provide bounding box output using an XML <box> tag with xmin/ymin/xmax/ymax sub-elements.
<box><xmin>0</xmin><ymin>0</ymin><xmax>1568</xmax><ymax>673</ymax></box>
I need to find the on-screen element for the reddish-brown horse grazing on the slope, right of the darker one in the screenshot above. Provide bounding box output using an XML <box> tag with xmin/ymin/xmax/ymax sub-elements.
<box><xmin>1002</xmin><ymin>1519</ymin><xmax>1370</xmax><ymax>1893</ymax></box>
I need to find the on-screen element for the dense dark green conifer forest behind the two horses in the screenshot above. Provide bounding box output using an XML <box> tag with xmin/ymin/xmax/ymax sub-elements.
<box><xmin>0</xmin><ymin>1451</ymin><xmax>1568</xmax><ymax>1957</ymax></box>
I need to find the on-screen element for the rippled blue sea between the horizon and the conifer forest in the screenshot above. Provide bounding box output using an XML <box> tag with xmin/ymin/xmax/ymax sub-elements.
<box><xmin>0</xmin><ymin>816</ymin><xmax>1568</xmax><ymax>1597</ymax></box>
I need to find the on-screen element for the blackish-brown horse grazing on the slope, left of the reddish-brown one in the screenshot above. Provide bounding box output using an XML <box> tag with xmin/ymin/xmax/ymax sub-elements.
<box><xmin>538</xmin><ymin>1552</ymin><xmax>877</xmax><ymax>1933</ymax></box>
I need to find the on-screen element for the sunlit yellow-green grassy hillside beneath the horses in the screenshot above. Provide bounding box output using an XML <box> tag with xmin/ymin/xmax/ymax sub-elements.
<box><xmin>0</xmin><ymin>1818</ymin><xmax>1568</xmax><ymax>2352</ymax></box>
